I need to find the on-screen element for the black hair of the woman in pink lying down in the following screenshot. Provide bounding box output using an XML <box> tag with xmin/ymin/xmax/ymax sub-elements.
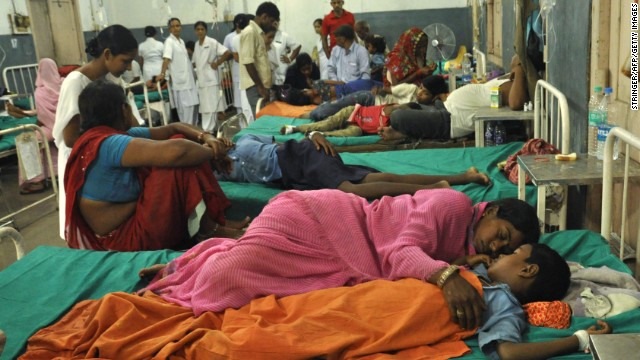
<box><xmin>487</xmin><ymin>198</ymin><xmax>540</xmax><ymax>244</ymax></box>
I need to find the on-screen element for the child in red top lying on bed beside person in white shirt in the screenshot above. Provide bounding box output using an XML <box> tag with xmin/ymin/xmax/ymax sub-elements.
<box><xmin>280</xmin><ymin>102</ymin><xmax>422</xmax><ymax>136</ymax></box>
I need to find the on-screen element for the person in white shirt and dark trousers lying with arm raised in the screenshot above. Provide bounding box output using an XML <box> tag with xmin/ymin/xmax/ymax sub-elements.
<box><xmin>379</xmin><ymin>56</ymin><xmax>529</xmax><ymax>140</ymax></box>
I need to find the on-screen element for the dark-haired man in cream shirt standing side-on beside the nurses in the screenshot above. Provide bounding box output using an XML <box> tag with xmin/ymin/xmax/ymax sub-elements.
<box><xmin>238</xmin><ymin>2</ymin><xmax>280</xmax><ymax>117</ymax></box>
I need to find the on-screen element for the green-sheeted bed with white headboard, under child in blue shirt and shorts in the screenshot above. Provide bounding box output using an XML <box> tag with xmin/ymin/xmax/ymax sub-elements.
<box><xmin>220</xmin><ymin>81</ymin><xmax>570</xmax><ymax>219</ymax></box>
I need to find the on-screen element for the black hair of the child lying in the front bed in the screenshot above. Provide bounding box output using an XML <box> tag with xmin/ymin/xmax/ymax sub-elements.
<box><xmin>520</xmin><ymin>244</ymin><xmax>571</xmax><ymax>303</ymax></box>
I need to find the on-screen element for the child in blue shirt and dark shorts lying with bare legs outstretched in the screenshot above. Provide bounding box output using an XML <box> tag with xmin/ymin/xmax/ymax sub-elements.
<box><xmin>214</xmin><ymin>131</ymin><xmax>490</xmax><ymax>199</ymax></box>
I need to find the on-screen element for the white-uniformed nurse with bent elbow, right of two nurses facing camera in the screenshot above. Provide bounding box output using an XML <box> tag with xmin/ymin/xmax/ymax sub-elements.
<box><xmin>192</xmin><ymin>21</ymin><xmax>233</xmax><ymax>132</ymax></box>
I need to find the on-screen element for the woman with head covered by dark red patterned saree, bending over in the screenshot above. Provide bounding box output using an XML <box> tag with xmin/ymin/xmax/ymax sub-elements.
<box><xmin>383</xmin><ymin>27</ymin><xmax>436</xmax><ymax>86</ymax></box>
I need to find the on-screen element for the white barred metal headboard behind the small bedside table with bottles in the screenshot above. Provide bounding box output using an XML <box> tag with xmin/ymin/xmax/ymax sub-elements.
<box><xmin>533</xmin><ymin>80</ymin><xmax>570</xmax><ymax>154</ymax></box>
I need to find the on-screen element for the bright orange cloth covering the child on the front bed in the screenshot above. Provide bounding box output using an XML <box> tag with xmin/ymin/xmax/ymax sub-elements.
<box><xmin>21</xmin><ymin>272</ymin><xmax>481</xmax><ymax>359</ymax></box>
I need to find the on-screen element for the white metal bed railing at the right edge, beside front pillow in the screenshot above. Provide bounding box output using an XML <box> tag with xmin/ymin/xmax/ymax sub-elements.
<box><xmin>600</xmin><ymin>127</ymin><xmax>640</xmax><ymax>276</ymax></box>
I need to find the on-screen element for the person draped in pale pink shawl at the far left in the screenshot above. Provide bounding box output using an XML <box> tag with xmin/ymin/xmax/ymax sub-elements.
<box><xmin>7</xmin><ymin>58</ymin><xmax>62</xmax><ymax>194</ymax></box>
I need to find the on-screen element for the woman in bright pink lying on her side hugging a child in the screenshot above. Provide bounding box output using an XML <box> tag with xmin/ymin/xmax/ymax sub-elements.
<box><xmin>141</xmin><ymin>189</ymin><xmax>540</xmax><ymax>329</ymax></box>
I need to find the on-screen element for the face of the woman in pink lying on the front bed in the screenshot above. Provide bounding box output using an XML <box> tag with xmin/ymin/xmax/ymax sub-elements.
<box><xmin>473</xmin><ymin>207</ymin><xmax>524</xmax><ymax>257</ymax></box>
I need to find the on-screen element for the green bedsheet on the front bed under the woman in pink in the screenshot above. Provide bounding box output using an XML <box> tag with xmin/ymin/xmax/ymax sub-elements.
<box><xmin>0</xmin><ymin>231</ymin><xmax>640</xmax><ymax>360</ymax></box>
